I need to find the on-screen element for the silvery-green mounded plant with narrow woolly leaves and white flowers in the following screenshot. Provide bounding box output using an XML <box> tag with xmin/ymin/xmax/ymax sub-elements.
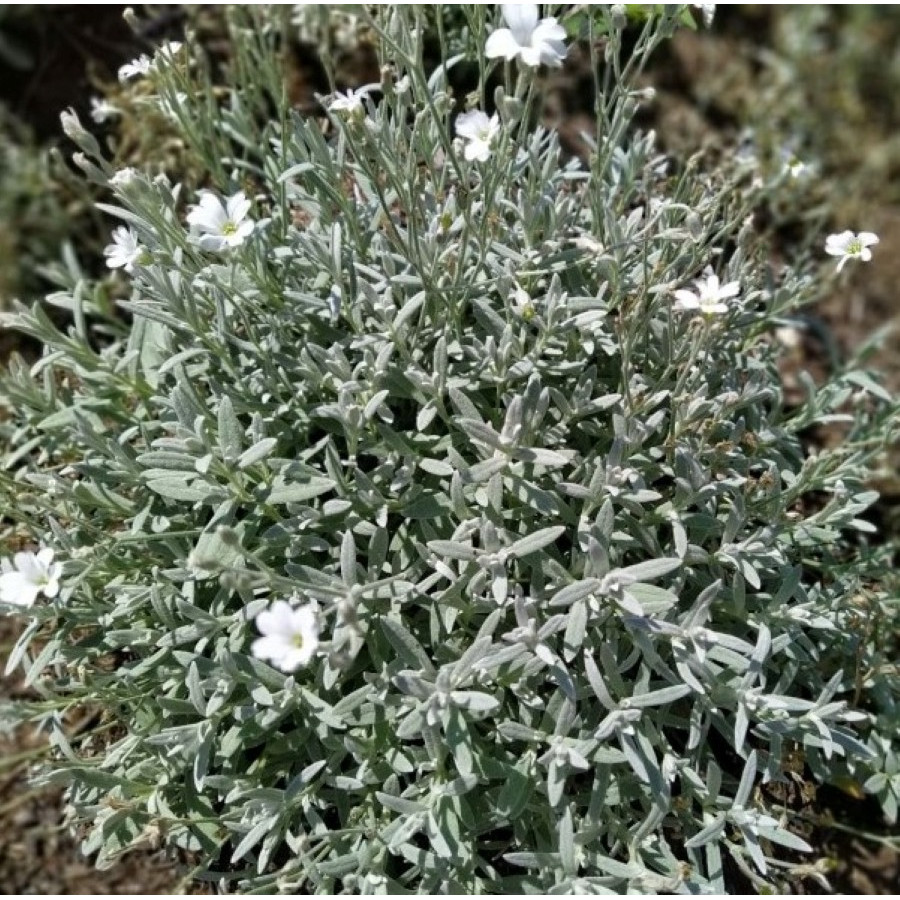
<box><xmin>0</xmin><ymin>6</ymin><xmax>898</xmax><ymax>893</ymax></box>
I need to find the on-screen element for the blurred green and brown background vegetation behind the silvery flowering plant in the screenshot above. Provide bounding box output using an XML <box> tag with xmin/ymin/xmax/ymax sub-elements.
<box><xmin>0</xmin><ymin>4</ymin><xmax>900</xmax><ymax>376</ymax></box>
